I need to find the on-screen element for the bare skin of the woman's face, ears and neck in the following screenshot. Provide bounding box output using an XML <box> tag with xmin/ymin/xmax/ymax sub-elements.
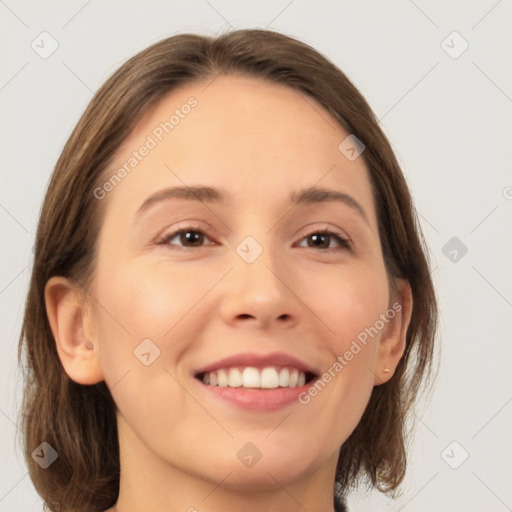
<box><xmin>46</xmin><ymin>76</ymin><xmax>412</xmax><ymax>512</ymax></box>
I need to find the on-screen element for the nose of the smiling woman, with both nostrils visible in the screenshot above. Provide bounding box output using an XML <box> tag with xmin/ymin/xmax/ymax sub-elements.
<box><xmin>222</xmin><ymin>238</ymin><xmax>301</xmax><ymax>328</ymax></box>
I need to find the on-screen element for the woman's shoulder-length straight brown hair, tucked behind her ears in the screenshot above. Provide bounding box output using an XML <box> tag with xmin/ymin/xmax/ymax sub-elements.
<box><xmin>19</xmin><ymin>30</ymin><xmax>437</xmax><ymax>512</ymax></box>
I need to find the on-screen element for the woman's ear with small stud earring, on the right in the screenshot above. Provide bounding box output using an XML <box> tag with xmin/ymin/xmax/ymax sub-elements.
<box><xmin>373</xmin><ymin>279</ymin><xmax>413</xmax><ymax>386</ymax></box>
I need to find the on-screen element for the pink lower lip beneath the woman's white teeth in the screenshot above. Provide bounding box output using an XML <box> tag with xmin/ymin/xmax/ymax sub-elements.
<box><xmin>195</xmin><ymin>379</ymin><xmax>314</xmax><ymax>411</ymax></box>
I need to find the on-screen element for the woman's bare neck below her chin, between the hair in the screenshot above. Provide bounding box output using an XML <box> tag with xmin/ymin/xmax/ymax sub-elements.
<box><xmin>109</xmin><ymin>418</ymin><xmax>338</xmax><ymax>512</ymax></box>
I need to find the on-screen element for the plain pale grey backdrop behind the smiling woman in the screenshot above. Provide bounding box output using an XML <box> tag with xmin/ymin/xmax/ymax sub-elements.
<box><xmin>0</xmin><ymin>0</ymin><xmax>512</xmax><ymax>512</ymax></box>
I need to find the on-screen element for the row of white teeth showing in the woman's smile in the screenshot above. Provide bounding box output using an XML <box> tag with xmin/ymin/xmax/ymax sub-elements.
<box><xmin>203</xmin><ymin>366</ymin><xmax>306</xmax><ymax>389</ymax></box>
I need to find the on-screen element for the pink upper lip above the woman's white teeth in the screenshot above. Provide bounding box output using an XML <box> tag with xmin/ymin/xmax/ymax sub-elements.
<box><xmin>194</xmin><ymin>352</ymin><xmax>320</xmax><ymax>377</ymax></box>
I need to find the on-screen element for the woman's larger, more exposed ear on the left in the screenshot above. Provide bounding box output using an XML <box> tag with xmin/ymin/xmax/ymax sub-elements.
<box><xmin>44</xmin><ymin>276</ymin><xmax>104</xmax><ymax>385</ymax></box>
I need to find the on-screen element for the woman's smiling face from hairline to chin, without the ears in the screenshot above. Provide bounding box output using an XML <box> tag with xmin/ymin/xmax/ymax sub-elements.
<box><xmin>83</xmin><ymin>76</ymin><xmax>404</xmax><ymax>489</ymax></box>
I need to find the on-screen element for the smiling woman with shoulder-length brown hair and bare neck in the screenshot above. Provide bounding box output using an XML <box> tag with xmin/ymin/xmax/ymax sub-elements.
<box><xmin>20</xmin><ymin>30</ymin><xmax>437</xmax><ymax>512</ymax></box>
